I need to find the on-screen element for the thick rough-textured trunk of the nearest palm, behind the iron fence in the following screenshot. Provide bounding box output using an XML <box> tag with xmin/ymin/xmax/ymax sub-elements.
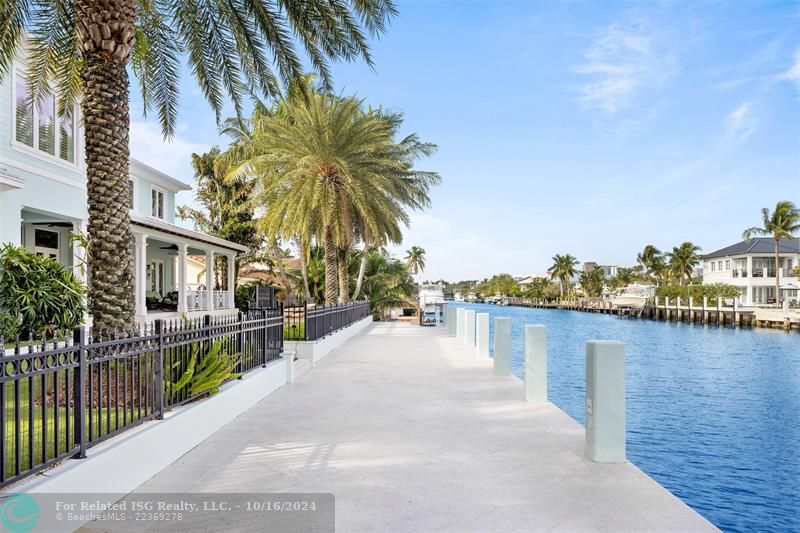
<box><xmin>75</xmin><ymin>0</ymin><xmax>136</xmax><ymax>331</ymax></box>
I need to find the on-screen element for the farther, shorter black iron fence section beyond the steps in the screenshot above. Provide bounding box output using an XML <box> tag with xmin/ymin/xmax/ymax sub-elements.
<box><xmin>283</xmin><ymin>301</ymin><xmax>370</xmax><ymax>341</ymax></box>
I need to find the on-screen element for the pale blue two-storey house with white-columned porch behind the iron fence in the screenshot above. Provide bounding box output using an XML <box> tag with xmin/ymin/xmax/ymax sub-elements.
<box><xmin>0</xmin><ymin>43</ymin><xmax>247</xmax><ymax>321</ymax></box>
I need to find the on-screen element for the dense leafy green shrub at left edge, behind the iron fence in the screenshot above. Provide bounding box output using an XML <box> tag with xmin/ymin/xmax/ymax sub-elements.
<box><xmin>0</xmin><ymin>244</ymin><xmax>86</xmax><ymax>335</ymax></box>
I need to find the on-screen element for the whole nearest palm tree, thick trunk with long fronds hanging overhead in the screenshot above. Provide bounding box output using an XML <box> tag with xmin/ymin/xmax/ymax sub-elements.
<box><xmin>0</xmin><ymin>0</ymin><xmax>396</xmax><ymax>328</ymax></box>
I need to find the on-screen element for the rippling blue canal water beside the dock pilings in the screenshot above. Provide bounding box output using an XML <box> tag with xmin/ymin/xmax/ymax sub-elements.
<box><xmin>456</xmin><ymin>303</ymin><xmax>800</xmax><ymax>532</ymax></box>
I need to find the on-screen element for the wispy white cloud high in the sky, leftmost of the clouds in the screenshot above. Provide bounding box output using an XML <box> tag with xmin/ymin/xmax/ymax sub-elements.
<box><xmin>573</xmin><ymin>20</ymin><xmax>676</xmax><ymax>114</ymax></box>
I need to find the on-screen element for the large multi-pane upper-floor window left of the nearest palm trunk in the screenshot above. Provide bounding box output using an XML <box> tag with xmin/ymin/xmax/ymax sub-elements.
<box><xmin>14</xmin><ymin>73</ymin><xmax>77</xmax><ymax>163</ymax></box>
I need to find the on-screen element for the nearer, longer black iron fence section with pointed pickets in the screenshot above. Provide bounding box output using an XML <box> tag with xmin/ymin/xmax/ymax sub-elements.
<box><xmin>0</xmin><ymin>308</ymin><xmax>284</xmax><ymax>487</ymax></box>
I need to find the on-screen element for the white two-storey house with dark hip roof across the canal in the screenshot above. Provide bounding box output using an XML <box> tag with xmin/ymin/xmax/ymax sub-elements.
<box><xmin>703</xmin><ymin>237</ymin><xmax>800</xmax><ymax>305</ymax></box>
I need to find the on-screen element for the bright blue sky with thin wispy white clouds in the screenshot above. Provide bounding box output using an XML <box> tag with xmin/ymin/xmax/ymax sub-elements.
<box><xmin>131</xmin><ymin>0</ymin><xmax>800</xmax><ymax>280</ymax></box>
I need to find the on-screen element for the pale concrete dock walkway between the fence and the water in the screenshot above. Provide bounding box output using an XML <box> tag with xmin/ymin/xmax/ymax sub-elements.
<box><xmin>104</xmin><ymin>323</ymin><xmax>715</xmax><ymax>532</ymax></box>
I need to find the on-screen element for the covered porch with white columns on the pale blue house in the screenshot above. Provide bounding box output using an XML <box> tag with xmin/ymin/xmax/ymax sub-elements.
<box><xmin>131</xmin><ymin>215</ymin><xmax>247</xmax><ymax>323</ymax></box>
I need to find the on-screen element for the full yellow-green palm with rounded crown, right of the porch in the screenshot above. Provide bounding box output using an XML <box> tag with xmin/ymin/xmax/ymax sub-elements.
<box><xmin>231</xmin><ymin>88</ymin><xmax>440</xmax><ymax>304</ymax></box>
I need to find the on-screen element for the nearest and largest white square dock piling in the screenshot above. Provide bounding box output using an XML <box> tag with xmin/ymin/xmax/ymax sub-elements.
<box><xmin>586</xmin><ymin>341</ymin><xmax>626</xmax><ymax>463</ymax></box>
